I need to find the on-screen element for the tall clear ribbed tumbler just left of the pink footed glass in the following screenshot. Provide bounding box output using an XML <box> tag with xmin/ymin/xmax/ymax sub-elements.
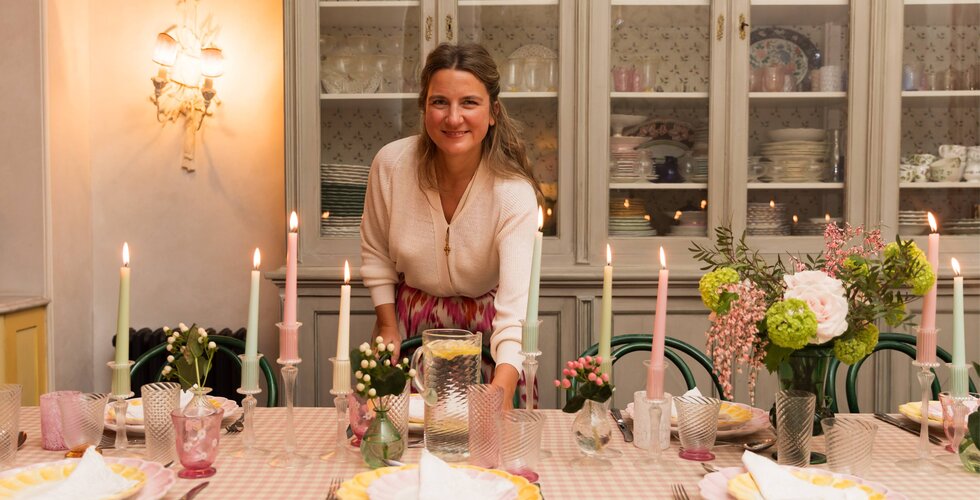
<box><xmin>140</xmin><ymin>382</ymin><xmax>180</xmax><ymax>464</ymax></box>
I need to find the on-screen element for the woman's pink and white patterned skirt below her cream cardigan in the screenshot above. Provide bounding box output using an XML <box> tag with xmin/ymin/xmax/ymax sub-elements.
<box><xmin>395</xmin><ymin>281</ymin><xmax>538</xmax><ymax>402</ymax></box>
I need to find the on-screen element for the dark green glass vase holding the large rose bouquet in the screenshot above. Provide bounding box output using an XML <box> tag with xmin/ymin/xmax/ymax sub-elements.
<box><xmin>769</xmin><ymin>345</ymin><xmax>834</xmax><ymax>436</ymax></box>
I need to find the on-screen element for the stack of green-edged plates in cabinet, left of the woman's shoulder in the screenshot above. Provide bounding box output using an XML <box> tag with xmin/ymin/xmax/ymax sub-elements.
<box><xmin>320</xmin><ymin>164</ymin><xmax>371</xmax><ymax>236</ymax></box>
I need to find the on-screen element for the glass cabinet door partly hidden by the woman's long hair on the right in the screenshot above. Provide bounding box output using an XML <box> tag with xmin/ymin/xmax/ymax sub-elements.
<box><xmin>456</xmin><ymin>0</ymin><xmax>561</xmax><ymax>236</ymax></box>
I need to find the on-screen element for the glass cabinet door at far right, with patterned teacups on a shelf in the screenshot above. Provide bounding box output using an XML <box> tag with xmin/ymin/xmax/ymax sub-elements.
<box><xmin>900</xmin><ymin>0</ymin><xmax>980</xmax><ymax>242</ymax></box>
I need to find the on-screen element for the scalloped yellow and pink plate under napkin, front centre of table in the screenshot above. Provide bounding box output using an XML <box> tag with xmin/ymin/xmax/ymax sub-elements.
<box><xmin>337</xmin><ymin>465</ymin><xmax>541</xmax><ymax>500</ymax></box>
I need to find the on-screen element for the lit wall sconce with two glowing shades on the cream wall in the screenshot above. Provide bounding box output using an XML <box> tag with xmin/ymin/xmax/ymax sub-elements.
<box><xmin>150</xmin><ymin>0</ymin><xmax>224</xmax><ymax>172</ymax></box>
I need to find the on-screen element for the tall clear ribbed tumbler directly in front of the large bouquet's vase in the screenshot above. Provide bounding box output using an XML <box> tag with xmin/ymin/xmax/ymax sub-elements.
<box><xmin>776</xmin><ymin>389</ymin><xmax>817</xmax><ymax>467</ymax></box>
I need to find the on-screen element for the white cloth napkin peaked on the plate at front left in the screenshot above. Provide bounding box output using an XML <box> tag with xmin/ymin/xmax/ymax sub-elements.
<box><xmin>32</xmin><ymin>446</ymin><xmax>138</xmax><ymax>500</ymax></box>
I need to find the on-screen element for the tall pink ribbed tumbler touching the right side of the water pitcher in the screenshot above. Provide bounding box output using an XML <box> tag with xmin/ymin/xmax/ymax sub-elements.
<box><xmin>466</xmin><ymin>384</ymin><xmax>504</xmax><ymax>469</ymax></box>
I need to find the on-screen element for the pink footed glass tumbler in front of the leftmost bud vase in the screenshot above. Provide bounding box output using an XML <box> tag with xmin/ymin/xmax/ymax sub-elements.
<box><xmin>170</xmin><ymin>408</ymin><xmax>225</xmax><ymax>479</ymax></box>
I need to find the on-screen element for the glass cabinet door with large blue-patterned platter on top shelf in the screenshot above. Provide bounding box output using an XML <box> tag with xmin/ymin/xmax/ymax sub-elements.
<box><xmin>733</xmin><ymin>0</ymin><xmax>859</xmax><ymax>237</ymax></box>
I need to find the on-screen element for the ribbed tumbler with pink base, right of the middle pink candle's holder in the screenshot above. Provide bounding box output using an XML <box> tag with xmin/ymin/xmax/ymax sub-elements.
<box><xmin>674</xmin><ymin>396</ymin><xmax>721</xmax><ymax>462</ymax></box>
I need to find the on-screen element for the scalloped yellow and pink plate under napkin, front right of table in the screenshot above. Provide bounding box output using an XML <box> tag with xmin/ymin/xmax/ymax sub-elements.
<box><xmin>698</xmin><ymin>467</ymin><xmax>907</xmax><ymax>500</ymax></box>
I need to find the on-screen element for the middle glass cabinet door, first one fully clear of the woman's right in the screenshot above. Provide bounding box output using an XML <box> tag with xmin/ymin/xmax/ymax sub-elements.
<box><xmin>607</xmin><ymin>0</ymin><xmax>720</xmax><ymax>242</ymax></box>
